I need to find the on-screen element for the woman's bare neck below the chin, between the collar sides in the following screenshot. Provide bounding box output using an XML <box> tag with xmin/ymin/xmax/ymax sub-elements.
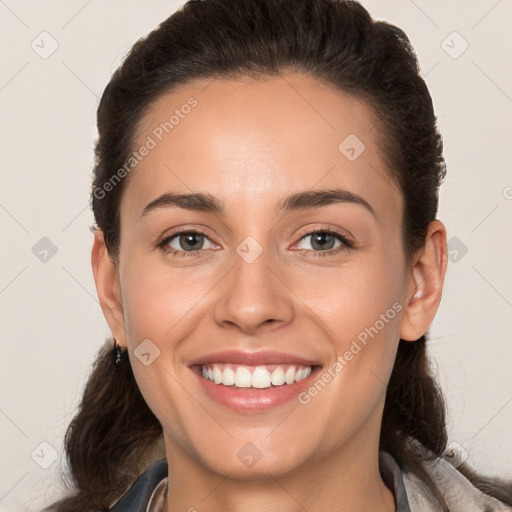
<box><xmin>163</xmin><ymin>428</ymin><xmax>395</xmax><ymax>512</ymax></box>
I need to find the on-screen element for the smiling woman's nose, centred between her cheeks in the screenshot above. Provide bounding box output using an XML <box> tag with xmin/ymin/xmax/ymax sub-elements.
<box><xmin>214</xmin><ymin>245</ymin><xmax>294</xmax><ymax>334</ymax></box>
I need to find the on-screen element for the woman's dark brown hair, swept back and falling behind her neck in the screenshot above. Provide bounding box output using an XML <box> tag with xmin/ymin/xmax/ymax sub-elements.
<box><xmin>46</xmin><ymin>0</ymin><xmax>512</xmax><ymax>512</ymax></box>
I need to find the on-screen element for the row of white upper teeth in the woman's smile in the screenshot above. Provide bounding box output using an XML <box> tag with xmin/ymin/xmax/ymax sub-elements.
<box><xmin>201</xmin><ymin>363</ymin><xmax>312</xmax><ymax>389</ymax></box>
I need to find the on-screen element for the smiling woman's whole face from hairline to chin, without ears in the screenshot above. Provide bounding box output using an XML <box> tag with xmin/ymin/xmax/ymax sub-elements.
<box><xmin>103</xmin><ymin>73</ymin><xmax>416</xmax><ymax>478</ymax></box>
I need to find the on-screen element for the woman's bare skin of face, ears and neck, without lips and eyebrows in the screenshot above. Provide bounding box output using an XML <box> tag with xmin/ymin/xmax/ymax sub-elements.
<box><xmin>92</xmin><ymin>73</ymin><xmax>447</xmax><ymax>512</ymax></box>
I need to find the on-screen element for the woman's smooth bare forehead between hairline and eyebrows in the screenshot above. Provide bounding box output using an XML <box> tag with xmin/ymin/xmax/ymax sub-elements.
<box><xmin>122</xmin><ymin>73</ymin><xmax>402</xmax><ymax>226</ymax></box>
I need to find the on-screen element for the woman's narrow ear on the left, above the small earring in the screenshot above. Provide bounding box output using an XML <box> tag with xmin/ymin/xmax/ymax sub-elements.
<box><xmin>91</xmin><ymin>229</ymin><xmax>126</xmax><ymax>348</ymax></box>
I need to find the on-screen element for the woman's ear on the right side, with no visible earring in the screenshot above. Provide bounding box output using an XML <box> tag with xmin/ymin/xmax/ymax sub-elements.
<box><xmin>400</xmin><ymin>220</ymin><xmax>448</xmax><ymax>341</ymax></box>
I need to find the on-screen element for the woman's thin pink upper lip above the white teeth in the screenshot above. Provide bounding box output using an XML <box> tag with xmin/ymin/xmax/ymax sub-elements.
<box><xmin>189</xmin><ymin>350</ymin><xmax>320</xmax><ymax>366</ymax></box>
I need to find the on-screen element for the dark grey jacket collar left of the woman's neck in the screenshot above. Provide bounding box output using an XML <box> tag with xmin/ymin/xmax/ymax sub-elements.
<box><xmin>109</xmin><ymin>459</ymin><xmax>167</xmax><ymax>512</ymax></box>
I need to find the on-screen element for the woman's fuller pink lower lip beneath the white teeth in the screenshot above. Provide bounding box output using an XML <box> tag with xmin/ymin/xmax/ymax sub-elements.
<box><xmin>191</xmin><ymin>366</ymin><xmax>321</xmax><ymax>412</ymax></box>
